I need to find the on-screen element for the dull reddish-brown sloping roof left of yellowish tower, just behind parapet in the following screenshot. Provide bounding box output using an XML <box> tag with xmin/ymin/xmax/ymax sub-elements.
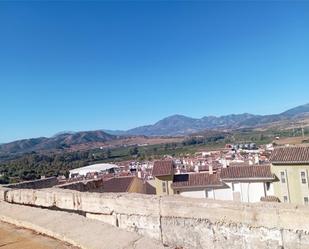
<box><xmin>103</xmin><ymin>176</ymin><xmax>134</xmax><ymax>193</ymax></box>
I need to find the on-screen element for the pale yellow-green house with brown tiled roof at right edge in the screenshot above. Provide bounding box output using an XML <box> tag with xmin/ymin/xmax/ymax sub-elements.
<box><xmin>270</xmin><ymin>146</ymin><xmax>309</xmax><ymax>205</ymax></box>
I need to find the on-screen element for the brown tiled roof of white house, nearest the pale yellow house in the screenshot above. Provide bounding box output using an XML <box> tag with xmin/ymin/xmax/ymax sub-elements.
<box><xmin>220</xmin><ymin>165</ymin><xmax>274</xmax><ymax>180</ymax></box>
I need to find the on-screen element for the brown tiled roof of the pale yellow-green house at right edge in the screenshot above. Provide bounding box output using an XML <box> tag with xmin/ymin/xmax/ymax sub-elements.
<box><xmin>270</xmin><ymin>147</ymin><xmax>309</xmax><ymax>164</ymax></box>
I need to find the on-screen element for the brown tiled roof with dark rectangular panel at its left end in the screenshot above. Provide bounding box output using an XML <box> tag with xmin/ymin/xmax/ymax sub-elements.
<box><xmin>172</xmin><ymin>173</ymin><xmax>223</xmax><ymax>189</ymax></box>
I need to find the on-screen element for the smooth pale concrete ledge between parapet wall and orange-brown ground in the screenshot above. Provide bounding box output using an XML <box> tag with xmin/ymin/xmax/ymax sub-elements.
<box><xmin>0</xmin><ymin>201</ymin><xmax>168</xmax><ymax>249</ymax></box>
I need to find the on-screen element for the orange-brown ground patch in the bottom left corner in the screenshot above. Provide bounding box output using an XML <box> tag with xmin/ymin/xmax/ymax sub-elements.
<box><xmin>0</xmin><ymin>222</ymin><xmax>78</xmax><ymax>249</ymax></box>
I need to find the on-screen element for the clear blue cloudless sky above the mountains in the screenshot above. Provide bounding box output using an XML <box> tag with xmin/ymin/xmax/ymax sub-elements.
<box><xmin>0</xmin><ymin>1</ymin><xmax>309</xmax><ymax>142</ymax></box>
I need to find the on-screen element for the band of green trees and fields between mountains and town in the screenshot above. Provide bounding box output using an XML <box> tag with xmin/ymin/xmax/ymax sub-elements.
<box><xmin>0</xmin><ymin>130</ymin><xmax>309</xmax><ymax>184</ymax></box>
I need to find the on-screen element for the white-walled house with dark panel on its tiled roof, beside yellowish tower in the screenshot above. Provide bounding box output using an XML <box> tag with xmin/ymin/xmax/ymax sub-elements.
<box><xmin>171</xmin><ymin>173</ymin><xmax>229</xmax><ymax>199</ymax></box>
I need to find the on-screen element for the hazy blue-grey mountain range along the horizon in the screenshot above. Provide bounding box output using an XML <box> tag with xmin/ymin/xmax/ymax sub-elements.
<box><xmin>0</xmin><ymin>104</ymin><xmax>309</xmax><ymax>155</ymax></box>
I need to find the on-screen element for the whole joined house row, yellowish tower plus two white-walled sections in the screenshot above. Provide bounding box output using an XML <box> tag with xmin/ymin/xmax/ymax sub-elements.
<box><xmin>152</xmin><ymin>161</ymin><xmax>276</xmax><ymax>203</ymax></box>
